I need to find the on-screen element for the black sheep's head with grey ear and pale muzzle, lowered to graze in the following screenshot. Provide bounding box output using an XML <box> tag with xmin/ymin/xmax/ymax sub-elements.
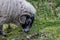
<box><xmin>20</xmin><ymin>15</ymin><xmax>34</xmax><ymax>32</ymax></box>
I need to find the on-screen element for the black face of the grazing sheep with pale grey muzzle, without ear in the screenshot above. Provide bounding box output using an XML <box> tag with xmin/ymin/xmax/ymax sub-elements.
<box><xmin>21</xmin><ymin>16</ymin><xmax>34</xmax><ymax>32</ymax></box>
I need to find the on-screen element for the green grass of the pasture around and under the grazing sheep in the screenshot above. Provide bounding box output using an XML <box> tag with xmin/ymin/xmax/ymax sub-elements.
<box><xmin>0</xmin><ymin>0</ymin><xmax>60</xmax><ymax>40</ymax></box>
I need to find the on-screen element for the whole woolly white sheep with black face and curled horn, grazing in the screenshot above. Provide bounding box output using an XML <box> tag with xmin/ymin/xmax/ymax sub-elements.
<box><xmin>0</xmin><ymin>0</ymin><xmax>36</xmax><ymax>36</ymax></box>
